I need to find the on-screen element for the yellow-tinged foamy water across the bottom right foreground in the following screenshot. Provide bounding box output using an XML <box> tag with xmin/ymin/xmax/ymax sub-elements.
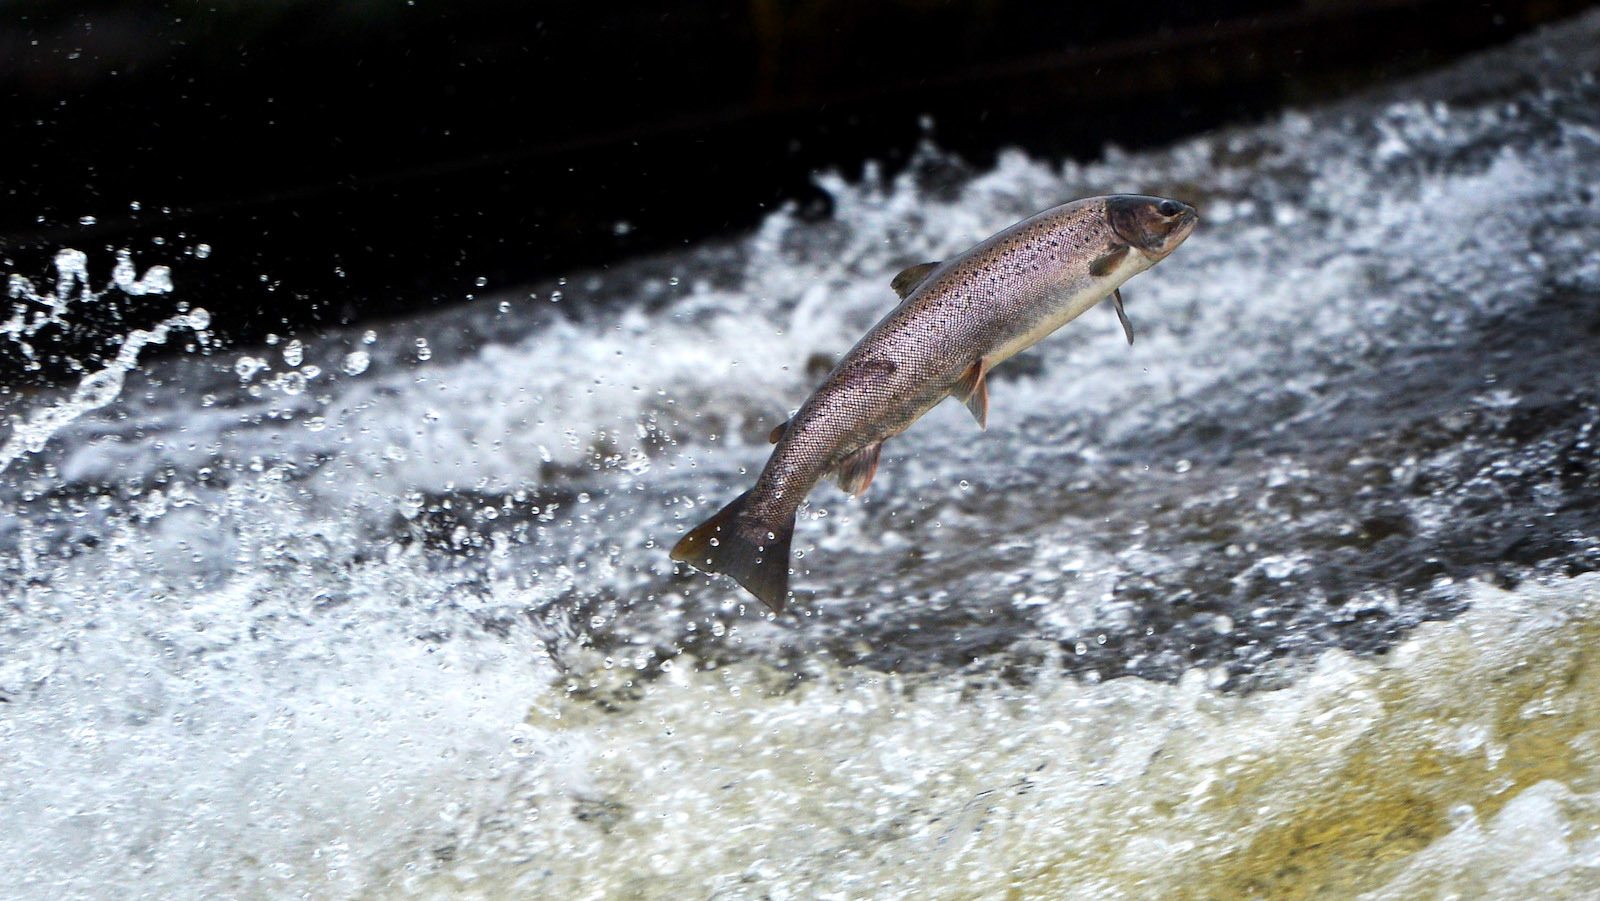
<box><xmin>411</xmin><ymin>576</ymin><xmax>1600</xmax><ymax>898</ymax></box>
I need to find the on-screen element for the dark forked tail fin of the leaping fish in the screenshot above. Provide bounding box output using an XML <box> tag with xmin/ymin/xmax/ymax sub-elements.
<box><xmin>672</xmin><ymin>491</ymin><xmax>795</xmax><ymax>613</ymax></box>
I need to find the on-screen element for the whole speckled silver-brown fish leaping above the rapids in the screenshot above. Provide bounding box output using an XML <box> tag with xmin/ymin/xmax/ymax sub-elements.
<box><xmin>672</xmin><ymin>194</ymin><xmax>1200</xmax><ymax>613</ymax></box>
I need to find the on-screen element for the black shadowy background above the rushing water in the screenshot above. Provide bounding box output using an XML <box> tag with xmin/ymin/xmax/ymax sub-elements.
<box><xmin>0</xmin><ymin>0</ymin><xmax>1592</xmax><ymax>381</ymax></box>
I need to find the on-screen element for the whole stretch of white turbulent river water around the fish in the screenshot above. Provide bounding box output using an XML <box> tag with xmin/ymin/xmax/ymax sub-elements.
<box><xmin>0</xmin><ymin>16</ymin><xmax>1600</xmax><ymax>899</ymax></box>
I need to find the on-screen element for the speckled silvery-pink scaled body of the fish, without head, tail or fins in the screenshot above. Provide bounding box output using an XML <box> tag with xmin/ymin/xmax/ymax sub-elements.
<box><xmin>749</xmin><ymin>197</ymin><xmax>1125</xmax><ymax>522</ymax></box>
